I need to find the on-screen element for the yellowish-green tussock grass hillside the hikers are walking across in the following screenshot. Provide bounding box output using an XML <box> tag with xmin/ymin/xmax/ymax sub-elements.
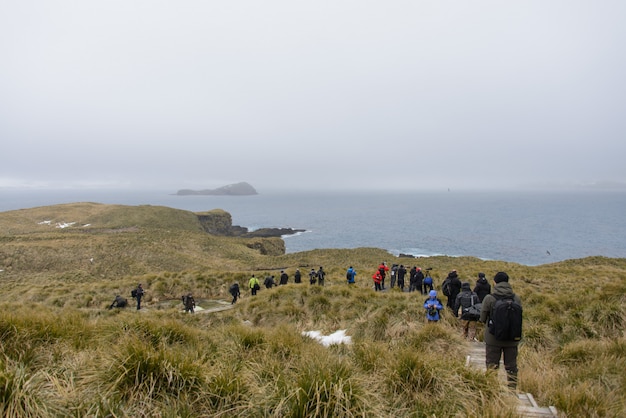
<box><xmin>0</xmin><ymin>203</ymin><xmax>626</xmax><ymax>417</ymax></box>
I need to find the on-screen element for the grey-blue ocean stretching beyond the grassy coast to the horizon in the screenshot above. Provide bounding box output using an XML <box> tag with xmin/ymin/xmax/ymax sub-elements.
<box><xmin>0</xmin><ymin>189</ymin><xmax>626</xmax><ymax>265</ymax></box>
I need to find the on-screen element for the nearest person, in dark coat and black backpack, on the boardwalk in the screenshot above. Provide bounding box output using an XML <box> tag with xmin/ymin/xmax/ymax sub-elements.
<box><xmin>480</xmin><ymin>271</ymin><xmax>522</xmax><ymax>389</ymax></box>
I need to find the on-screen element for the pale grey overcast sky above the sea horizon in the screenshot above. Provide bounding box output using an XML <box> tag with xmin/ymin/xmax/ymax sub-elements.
<box><xmin>0</xmin><ymin>0</ymin><xmax>626</xmax><ymax>190</ymax></box>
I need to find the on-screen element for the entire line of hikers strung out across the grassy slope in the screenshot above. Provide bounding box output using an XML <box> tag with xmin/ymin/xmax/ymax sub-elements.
<box><xmin>109</xmin><ymin>262</ymin><xmax>522</xmax><ymax>388</ymax></box>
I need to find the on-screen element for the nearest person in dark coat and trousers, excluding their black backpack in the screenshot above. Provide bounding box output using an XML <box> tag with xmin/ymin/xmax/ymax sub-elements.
<box><xmin>480</xmin><ymin>271</ymin><xmax>522</xmax><ymax>389</ymax></box>
